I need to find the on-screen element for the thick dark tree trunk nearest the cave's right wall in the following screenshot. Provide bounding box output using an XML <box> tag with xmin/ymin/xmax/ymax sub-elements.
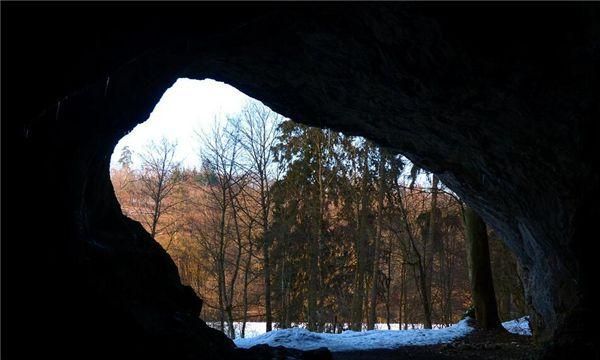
<box><xmin>465</xmin><ymin>207</ymin><xmax>501</xmax><ymax>329</ymax></box>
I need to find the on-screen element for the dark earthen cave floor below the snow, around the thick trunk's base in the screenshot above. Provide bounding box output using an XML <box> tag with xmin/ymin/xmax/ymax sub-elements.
<box><xmin>332</xmin><ymin>330</ymin><xmax>540</xmax><ymax>360</ymax></box>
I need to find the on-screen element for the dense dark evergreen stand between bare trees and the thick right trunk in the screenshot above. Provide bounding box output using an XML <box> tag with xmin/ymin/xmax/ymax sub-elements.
<box><xmin>274</xmin><ymin>122</ymin><xmax>478</xmax><ymax>329</ymax></box>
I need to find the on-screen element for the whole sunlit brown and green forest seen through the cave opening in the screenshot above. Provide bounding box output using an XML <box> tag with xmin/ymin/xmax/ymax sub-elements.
<box><xmin>111</xmin><ymin>101</ymin><xmax>527</xmax><ymax>338</ymax></box>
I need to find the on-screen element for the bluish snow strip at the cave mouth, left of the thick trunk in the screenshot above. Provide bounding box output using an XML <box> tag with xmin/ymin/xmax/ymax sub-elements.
<box><xmin>234</xmin><ymin>319</ymin><xmax>473</xmax><ymax>352</ymax></box>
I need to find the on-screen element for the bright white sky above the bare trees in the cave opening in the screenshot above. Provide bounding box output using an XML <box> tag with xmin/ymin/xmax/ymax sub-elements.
<box><xmin>111</xmin><ymin>78</ymin><xmax>252</xmax><ymax>168</ymax></box>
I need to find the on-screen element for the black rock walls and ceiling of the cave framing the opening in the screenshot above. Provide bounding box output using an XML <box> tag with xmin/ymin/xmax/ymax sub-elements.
<box><xmin>2</xmin><ymin>2</ymin><xmax>600</xmax><ymax>359</ymax></box>
